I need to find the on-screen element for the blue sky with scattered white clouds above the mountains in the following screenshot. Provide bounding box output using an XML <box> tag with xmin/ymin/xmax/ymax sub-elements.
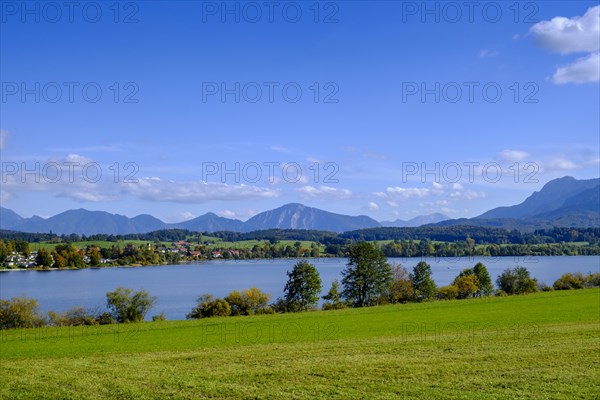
<box><xmin>0</xmin><ymin>1</ymin><xmax>600</xmax><ymax>222</ymax></box>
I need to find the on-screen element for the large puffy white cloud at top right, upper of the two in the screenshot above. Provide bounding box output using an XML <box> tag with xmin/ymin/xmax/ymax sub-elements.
<box><xmin>530</xmin><ymin>6</ymin><xmax>600</xmax><ymax>54</ymax></box>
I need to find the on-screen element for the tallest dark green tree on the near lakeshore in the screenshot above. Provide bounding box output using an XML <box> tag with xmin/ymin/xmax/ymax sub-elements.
<box><xmin>342</xmin><ymin>242</ymin><xmax>392</xmax><ymax>307</ymax></box>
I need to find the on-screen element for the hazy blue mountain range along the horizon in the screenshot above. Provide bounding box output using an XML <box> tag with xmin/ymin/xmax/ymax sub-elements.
<box><xmin>0</xmin><ymin>177</ymin><xmax>600</xmax><ymax>235</ymax></box>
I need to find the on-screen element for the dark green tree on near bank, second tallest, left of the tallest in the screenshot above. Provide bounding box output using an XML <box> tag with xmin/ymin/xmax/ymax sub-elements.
<box><xmin>283</xmin><ymin>261</ymin><xmax>322</xmax><ymax>311</ymax></box>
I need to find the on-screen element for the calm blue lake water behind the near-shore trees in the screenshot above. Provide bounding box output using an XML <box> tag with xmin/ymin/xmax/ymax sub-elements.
<box><xmin>0</xmin><ymin>256</ymin><xmax>600</xmax><ymax>319</ymax></box>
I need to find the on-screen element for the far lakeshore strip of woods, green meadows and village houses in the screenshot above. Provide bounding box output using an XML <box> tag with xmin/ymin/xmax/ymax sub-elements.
<box><xmin>0</xmin><ymin>227</ymin><xmax>600</xmax><ymax>269</ymax></box>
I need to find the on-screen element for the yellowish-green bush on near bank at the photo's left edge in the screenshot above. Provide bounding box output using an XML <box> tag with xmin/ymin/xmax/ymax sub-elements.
<box><xmin>0</xmin><ymin>296</ymin><xmax>46</xmax><ymax>329</ymax></box>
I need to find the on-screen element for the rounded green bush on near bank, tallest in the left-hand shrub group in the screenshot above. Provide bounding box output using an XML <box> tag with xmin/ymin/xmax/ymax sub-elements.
<box><xmin>106</xmin><ymin>287</ymin><xmax>156</xmax><ymax>322</ymax></box>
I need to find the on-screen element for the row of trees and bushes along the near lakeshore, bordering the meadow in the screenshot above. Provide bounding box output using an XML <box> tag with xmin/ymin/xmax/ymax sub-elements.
<box><xmin>0</xmin><ymin>242</ymin><xmax>600</xmax><ymax>329</ymax></box>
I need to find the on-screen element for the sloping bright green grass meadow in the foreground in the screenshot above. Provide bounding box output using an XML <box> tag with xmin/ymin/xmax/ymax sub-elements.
<box><xmin>0</xmin><ymin>289</ymin><xmax>600</xmax><ymax>399</ymax></box>
